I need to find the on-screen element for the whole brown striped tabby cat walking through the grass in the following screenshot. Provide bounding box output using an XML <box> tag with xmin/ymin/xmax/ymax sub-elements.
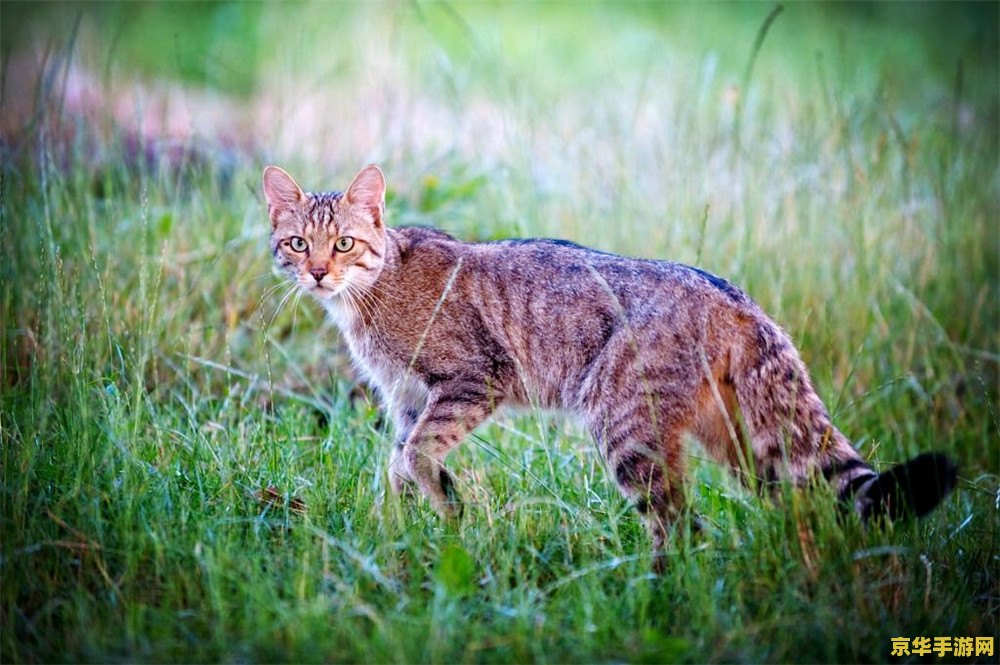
<box><xmin>264</xmin><ymin>165</ymin><xmax>955</xmax><ymax>564</ymax></box>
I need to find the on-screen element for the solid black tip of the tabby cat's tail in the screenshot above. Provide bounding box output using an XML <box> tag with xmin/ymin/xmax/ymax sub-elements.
<box><xmin>862</xmin><ymin>453</ymin><xmax>958</xmax><ymax>521</ymax></box>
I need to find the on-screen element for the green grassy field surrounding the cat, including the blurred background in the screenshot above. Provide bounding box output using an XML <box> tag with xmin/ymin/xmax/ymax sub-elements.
<box><xmin>0</xmin><ymin>2</ymin><xmax>1000</xmax><ymax>662</ymax></box>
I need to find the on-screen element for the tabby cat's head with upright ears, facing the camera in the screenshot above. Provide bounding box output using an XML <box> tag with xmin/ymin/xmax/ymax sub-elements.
<box><xmin>264</xmin><ymin>164</ymin><xmax>386</xmax><ymax>300</ymax></box>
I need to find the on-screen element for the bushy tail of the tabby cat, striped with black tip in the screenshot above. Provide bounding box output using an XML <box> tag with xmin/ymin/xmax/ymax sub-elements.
<box><xmin>732</xmin><ymin>321</ymin><xmax>956</xmax><ymax>522</ymax></box>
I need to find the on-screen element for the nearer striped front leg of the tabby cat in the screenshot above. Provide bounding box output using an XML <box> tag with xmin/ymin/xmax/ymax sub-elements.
<box><xmin>402</xmin><ymin>380</ymin><xmax>495</xmax><ymax>517</ymax></box>
